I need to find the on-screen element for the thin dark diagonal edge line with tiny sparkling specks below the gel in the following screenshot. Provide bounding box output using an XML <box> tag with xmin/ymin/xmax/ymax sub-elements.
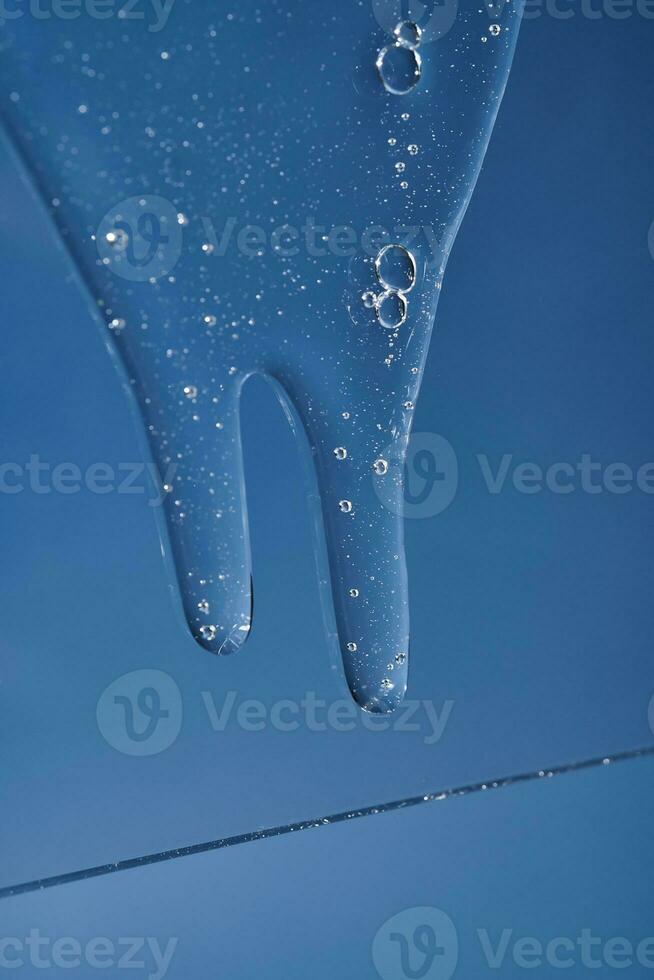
<box><xmin>0</xmin><ymin>746</ymin><xmax>654</xmax><ymax>899</ymax></box>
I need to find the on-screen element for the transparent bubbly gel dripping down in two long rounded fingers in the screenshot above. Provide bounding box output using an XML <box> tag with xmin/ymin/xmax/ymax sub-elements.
<box><xmin>0</xmin><ymin>0</ymin><xmax>520</xmax><ymax>711</ymax></box>
